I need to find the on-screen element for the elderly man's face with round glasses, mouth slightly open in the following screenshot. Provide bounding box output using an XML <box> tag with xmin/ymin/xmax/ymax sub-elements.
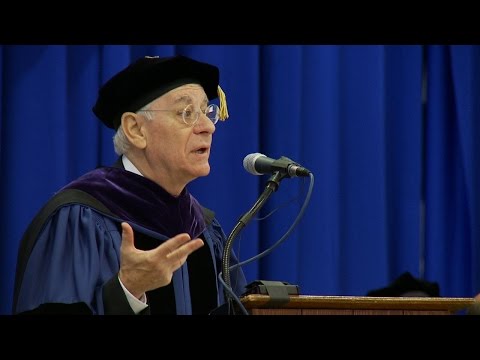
<box><xmin>140</xmin><ymin>84</ymin><xmax>215</xmax><ymax>187</ymax></box>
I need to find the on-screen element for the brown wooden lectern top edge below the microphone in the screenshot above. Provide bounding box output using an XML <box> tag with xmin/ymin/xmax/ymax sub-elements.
<box><xmin>241</xmin><ymin>294</ymin><xmax>476</xmax><ymax>315</ymax></box>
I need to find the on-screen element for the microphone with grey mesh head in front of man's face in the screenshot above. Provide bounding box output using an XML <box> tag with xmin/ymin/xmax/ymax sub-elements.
<box><xmin>243</xmin><ymin>153</ymin><xmax>310</xmax><ymax>177</ymax></box>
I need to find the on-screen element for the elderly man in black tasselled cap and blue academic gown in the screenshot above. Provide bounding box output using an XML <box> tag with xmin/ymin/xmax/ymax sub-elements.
<box><xmin>13</xmin><ymin>56</ymin><xmax>246</xmax><ymax>314</ymax></box>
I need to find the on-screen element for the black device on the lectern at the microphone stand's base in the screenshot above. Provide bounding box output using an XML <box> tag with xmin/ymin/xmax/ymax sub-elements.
<box><xmin>242</xmin><ymin>280</ymin><xmax>300</xmax><ymax>307</ymax></box>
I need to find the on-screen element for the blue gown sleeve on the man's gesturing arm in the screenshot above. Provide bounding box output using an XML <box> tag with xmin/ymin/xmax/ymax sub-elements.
<box><xmin>14</xmin><ymin>204</ymin><xmax>133</xmax><ymax>314</ymax></box>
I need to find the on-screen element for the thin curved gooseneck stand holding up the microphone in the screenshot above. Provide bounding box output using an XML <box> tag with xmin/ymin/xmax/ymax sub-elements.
<box><xmin>222</xmin><ymin>171</ymin><xmax>290</xmax><ymax>308</ymax></box>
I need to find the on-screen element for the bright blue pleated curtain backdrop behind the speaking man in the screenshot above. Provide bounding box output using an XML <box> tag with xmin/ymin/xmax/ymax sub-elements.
<box><xmin>0</xmin><ymin>45</ymin><xmax>480</xmax><ymax>314</ymax></box>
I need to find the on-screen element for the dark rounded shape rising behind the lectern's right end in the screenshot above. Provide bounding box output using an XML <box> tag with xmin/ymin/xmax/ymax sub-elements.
<box><xmin>367</xmin><ymin>272</ymin><xmax>440</xmax><ymax>297</ymax></box>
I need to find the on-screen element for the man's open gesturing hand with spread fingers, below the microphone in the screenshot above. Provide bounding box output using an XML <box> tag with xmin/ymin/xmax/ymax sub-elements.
<box><xmin>119</xmin><ymin>222</ymin><xmax>203</xmax><ymax>298</ymax></box>
